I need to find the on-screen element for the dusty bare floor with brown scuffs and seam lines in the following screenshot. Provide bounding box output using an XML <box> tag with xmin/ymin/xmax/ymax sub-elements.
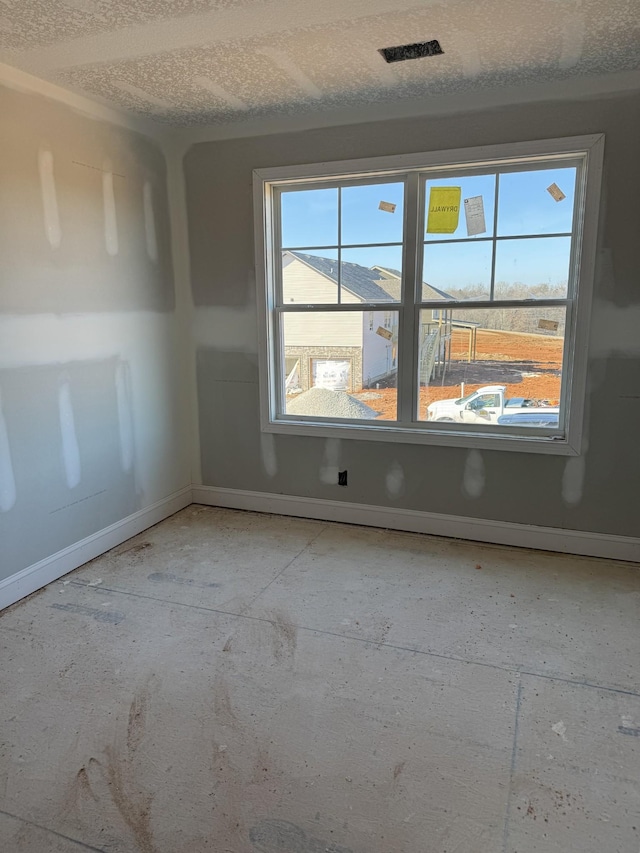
<box><xmin>0</xmin><ymin>507</ymin><xmax>640</xmax><ymax>853</ymax></box>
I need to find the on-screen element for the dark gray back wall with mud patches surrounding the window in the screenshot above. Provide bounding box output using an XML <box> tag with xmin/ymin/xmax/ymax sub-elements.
<box><xmin>184</xmin><ymin>90</ymin><xmax>640</xmax><ymax>536</ymax></box>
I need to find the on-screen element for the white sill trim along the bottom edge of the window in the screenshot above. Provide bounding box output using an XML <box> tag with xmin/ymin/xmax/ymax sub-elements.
<box><xmin>262</xmin><ymin>419</ymin><xmax>580</xmax><ymax>456</ymax></box>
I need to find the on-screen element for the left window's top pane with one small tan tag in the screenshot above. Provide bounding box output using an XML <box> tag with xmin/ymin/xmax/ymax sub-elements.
<box><xmin>341</xmin><ymin>183</ymin><xmax>404</xmax><ymax>245</ymax></box>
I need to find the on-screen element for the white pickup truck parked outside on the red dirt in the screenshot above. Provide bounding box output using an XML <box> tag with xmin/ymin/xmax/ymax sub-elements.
<box><xmin>427</xmin><ymin>385</ymin><xmax>558</xmax><ymax>424</ymax></box>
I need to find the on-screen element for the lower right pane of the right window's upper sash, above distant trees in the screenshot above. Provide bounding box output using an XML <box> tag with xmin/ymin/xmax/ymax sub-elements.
<box><xmin>494</xmin><ymin>237</ymin><xmax>571</xmax><ymax>299</ymax></box>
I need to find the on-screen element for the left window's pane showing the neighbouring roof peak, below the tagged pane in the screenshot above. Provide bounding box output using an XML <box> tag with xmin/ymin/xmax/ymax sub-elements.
<box><xmin>342</xmin><ymin>246</ymin><xmax>402</xmax><ymax>302</ymax></box>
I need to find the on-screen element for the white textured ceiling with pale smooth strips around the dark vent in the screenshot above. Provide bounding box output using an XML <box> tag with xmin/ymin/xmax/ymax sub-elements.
<box><xmin>0</xmin><ymin>0</ymin><xmax>640</xmax><ymax>125</ymax></box>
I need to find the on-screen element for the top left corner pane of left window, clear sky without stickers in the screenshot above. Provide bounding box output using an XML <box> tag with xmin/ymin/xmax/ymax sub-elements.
<box><xmin>280</xmin><ymin>187</ymin><xmax>338</xmax><ymax>248</ymax></box>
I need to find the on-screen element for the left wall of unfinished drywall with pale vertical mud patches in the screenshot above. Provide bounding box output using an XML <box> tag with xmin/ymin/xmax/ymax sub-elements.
<box><xmin>0</xmin><ymin>87</ymin><xmax>189</xmax><ymax>581</ymax></box>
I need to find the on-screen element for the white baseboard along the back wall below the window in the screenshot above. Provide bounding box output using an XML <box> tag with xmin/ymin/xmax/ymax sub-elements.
<box><xmin>193</xmin><ymin>486</ymin><xmax>640</xmax><ymax>562</ymax></box>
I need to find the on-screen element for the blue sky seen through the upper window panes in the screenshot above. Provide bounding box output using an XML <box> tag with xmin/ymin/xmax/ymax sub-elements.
<box><xmin>282</xmin><ymin>167</ymin><xmax>575</xmax><ymax>290</ymax></box>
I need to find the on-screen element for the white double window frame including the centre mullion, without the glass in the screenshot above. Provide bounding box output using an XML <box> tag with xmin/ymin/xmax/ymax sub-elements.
<box><xmin>253</xmin><ymin>134</ymin><xmax>604</xmax><ymax>456</ymax></box>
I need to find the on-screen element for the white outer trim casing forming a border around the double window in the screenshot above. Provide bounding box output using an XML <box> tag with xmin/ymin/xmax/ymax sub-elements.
<box><xmin>253</xmin><ymin>134</ymin><xmax>604</xmax><ymax>456</ymax></box>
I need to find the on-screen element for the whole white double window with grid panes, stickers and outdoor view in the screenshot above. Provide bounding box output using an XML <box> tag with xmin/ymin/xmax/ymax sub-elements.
<box><xmin>254</xmin><ymin>136</ymin><xmax>604</xmax><ymax>454</ymax></box>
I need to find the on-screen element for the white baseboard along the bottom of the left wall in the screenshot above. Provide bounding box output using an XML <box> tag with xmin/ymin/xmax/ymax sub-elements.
<box><xmin>0</xmin><ymin>486</ymin><xmax>192</xmax><ymax>610</ymax></box>
